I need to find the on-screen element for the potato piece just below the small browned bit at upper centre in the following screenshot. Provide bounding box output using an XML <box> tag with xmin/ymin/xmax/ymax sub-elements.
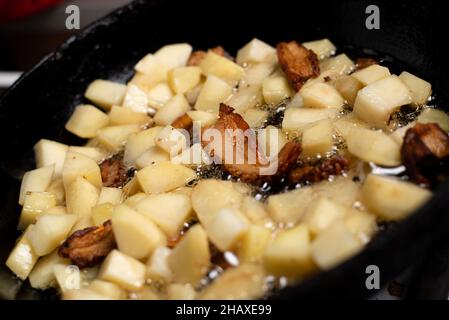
<box><xmin>200</xmin><ymin>50</ymin><xmax>244</xmax><ymax>81</ymax></box>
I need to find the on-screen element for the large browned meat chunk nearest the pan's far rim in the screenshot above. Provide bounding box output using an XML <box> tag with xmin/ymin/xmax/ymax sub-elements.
<box><xmin>276</xmin><ymin>41</ymin><xmax>320</xmax><ymax>91</ymax></box>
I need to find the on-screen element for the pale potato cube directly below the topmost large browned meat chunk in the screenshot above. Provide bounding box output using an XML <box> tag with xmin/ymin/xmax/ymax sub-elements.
<box><xmin>301</xmin><ymin>83</ymin><xmax>344</xmax><ymax>108</ymax></box>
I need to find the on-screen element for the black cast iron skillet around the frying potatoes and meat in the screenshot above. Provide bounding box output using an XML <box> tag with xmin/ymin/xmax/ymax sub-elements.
<box><xmin>0</xmin><ymin>0</ymin><xmax>449</xmax><ymax>298</ymax></box>
